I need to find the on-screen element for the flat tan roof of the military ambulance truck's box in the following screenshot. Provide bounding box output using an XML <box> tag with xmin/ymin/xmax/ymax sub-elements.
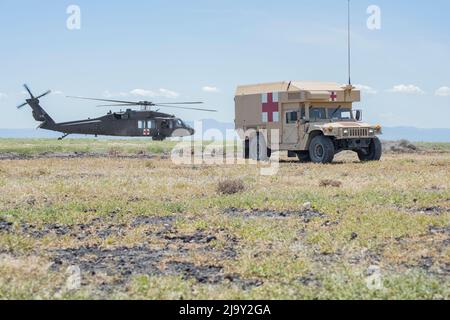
<box><xmin>236</xmin><ymin>81</ymin><xmax>359</xmax><ymax>96</ymax></box>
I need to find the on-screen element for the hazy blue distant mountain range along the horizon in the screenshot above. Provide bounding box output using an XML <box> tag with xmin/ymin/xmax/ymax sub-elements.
<box><xmin>0</xmin><ymin>119</ymin><xmax>450</xmax><ymax>142</ymax></box>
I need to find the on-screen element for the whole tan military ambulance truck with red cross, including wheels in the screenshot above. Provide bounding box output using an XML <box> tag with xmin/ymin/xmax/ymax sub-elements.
<box><xmin>235</xmin><ymin>81</ymin><xmax>382</xmax><ymax>163</ymax></box>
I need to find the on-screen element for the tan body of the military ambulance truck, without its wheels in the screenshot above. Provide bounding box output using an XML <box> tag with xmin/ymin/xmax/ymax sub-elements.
<box><xmin>235</xmin><ymin>81</ymin><xmax>381</xmax><ymax>162</ymax></box>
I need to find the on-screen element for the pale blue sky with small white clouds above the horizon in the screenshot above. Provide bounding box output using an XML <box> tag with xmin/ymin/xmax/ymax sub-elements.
<box><xmin>0</xmin><ymin>0</ymin><xmax>450</xmax><ymax>128</ymax></box>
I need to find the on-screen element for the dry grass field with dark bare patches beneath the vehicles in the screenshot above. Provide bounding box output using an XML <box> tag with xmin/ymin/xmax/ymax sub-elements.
<box><xmin>0</xmin><ymin>140</ymin><xmax>450</xmax><ymax>299</ymax></box>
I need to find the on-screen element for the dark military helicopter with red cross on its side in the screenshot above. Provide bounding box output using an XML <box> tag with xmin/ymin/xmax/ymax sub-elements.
<box><xmin>17</xmin><ymin>84</ymin><xmax>217</xmax><ymax>141</ymax></box>
